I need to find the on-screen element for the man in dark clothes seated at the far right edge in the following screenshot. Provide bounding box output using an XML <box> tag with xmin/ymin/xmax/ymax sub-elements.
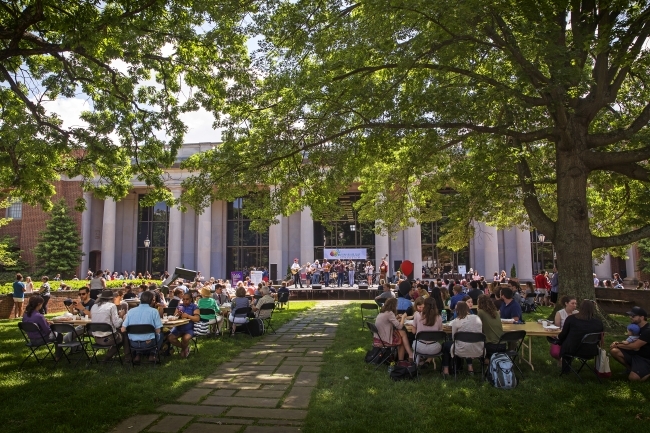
<box><xmin>608</xmin><ymin>307</ymin><xmax>650</xmax><ymax>382</ymax></box>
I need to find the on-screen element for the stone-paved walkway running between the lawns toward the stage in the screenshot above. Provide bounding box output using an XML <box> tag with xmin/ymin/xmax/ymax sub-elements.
<box><xmin>111</xmin><ymin>301</ymin><xmax>346</xmax><ymax>433</ymax></box>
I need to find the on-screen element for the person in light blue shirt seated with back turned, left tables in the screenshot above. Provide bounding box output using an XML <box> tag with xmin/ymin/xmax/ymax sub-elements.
<box><xmin>122</xmin><ymin>291</ymin><xmax>163</xmax><ymax>364</ymax></box>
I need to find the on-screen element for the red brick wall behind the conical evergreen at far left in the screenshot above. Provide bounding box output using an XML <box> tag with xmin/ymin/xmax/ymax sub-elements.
<box><xmin>0</xmin><ymin>180</ymin><xmax>83</xmax><ymax>275</ymax></box>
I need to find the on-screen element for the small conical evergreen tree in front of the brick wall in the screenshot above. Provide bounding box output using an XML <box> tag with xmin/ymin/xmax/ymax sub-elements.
<box><xmin>34</xmin><ymin>200</ymin><xmax>83</xmax><ymax>275</ymax></box>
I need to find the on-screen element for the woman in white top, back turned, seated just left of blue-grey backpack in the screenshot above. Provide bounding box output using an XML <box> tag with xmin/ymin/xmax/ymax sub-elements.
<box><xmin>442</xmin><ymin>301</ymin><xmax>483</xmax><ymax>376</ymax></box>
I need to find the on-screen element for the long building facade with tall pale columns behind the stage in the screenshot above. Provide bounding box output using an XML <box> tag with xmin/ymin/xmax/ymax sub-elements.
<box><xmin>0</xmin><ymin>143</ymin><xmax>640</xmax><ymax>281</ymax></box>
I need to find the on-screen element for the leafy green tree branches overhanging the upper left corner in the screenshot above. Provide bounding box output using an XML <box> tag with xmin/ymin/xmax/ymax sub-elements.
<box><xmin>0</xmin><ymin>0</ymin><xmax>251</xmax><ymax>208</ymax></box>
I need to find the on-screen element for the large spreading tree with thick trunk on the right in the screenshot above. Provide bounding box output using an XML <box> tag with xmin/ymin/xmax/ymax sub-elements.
<box><xmin>183</xmin><ymin>0</ymin><xmax>650</xmax><ymax>298</ymax></box>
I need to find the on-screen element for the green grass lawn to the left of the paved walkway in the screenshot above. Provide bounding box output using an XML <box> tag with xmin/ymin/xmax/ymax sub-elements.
<box><xmin>0</xmin><ymin>301</ymin><xmax>315</xmax><ymax>433</ymax></box>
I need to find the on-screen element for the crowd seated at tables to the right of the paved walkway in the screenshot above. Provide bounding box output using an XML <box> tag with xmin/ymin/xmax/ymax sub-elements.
<box><xmin>373</xmin><ymin>271</ymin><xmax>650</xmax><ymax>381</ymax></box>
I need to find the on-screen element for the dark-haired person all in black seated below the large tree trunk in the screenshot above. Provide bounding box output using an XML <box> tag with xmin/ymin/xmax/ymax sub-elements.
<box><xmin>557</xmin><ymin>299</ymin><xmax>603</xmax><ymax>373</ymax></box>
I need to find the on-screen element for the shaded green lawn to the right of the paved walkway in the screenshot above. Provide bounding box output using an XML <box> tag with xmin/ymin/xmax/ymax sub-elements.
<box><xmin>303</xmin><ymin>304</ymin><xmax>650</xmax><ymax>433</ymax></box>
